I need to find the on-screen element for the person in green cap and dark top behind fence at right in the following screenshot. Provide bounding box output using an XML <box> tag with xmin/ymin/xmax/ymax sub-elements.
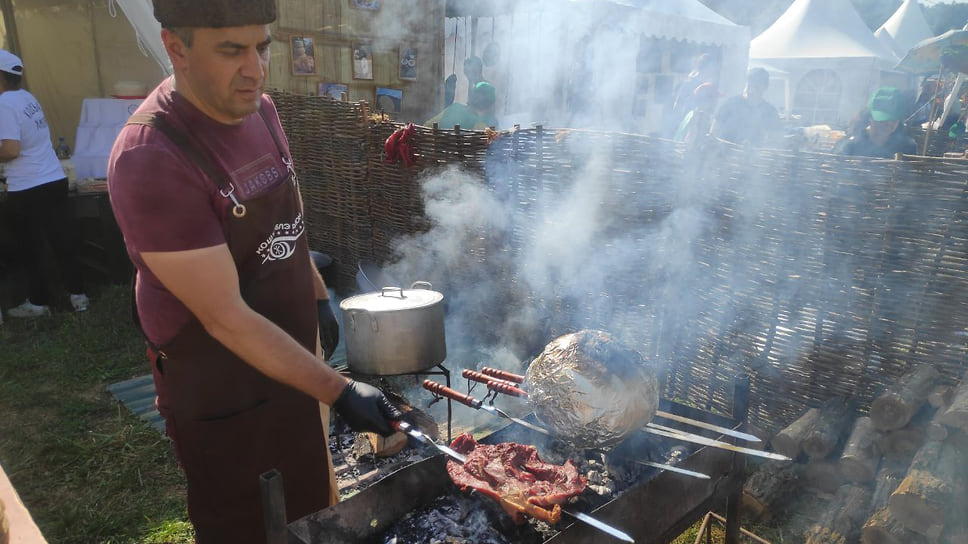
<box><xmin>843</xmin><ymin>87</ymin><xmax>917</xmax><ymax>159</ymax></box>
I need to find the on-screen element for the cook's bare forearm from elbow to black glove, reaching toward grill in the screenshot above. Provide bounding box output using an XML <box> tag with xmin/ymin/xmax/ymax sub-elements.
<box><xmin>207</xmin><ymin>310</ymin><xmax>349</xmax><ymax>405</ymax></box>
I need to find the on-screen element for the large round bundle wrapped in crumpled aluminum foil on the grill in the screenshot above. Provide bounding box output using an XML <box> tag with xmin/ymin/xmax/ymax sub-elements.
<box><xmin>525</xmin><ymin>330</ymin><xmax>659</xmax><ymax>448</ymax></box>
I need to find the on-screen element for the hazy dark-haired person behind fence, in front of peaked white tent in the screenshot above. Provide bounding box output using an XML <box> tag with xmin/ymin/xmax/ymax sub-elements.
<box><xmin>710</xmin><ymin>68</ymin><xmax>782</xmax><ymax>145</ymax></box>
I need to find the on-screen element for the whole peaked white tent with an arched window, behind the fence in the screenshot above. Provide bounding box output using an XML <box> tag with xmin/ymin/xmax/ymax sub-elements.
<box><xmin>750</xmin><ymin>0</ymin><xmax>898</xmax><ymax>125</ymax></box>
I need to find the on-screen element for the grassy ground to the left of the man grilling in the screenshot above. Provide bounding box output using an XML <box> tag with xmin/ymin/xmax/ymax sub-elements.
<box><xmin>0</xmin><ymin>287</ymin><xmax>192</xmax><ymax>544</ymax></box>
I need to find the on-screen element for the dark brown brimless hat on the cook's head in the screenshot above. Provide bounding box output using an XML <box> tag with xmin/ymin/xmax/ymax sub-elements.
<box><xmin>152</xmin><ymin>0</ymin><xmax>276</xmax><ymax>28</ymax></box>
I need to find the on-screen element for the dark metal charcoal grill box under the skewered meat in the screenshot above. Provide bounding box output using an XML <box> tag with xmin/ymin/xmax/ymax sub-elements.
<box><xmin>278</xmin><ymin>382</ymin><xmax>748</xmax><ymax>544</ymax></box>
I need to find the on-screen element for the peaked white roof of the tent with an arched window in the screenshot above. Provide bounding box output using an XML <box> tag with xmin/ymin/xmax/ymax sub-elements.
<box><xmin>750</xmin><ymin>0</ymin><xmax>897</xmax><ymax>64</ymax></box>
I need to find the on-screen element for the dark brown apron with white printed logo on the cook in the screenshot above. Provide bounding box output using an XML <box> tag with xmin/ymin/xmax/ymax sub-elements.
<box><xmin>129</xmin><ymin>107</ymin><xmax>335</xmax><ymax>544</ymax></box>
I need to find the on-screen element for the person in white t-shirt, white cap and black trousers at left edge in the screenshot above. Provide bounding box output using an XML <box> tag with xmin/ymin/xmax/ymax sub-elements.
<box><xmin>0</xmin><ymin>49</ymin><xmax>89</xmax><ymax>317</ymax></box>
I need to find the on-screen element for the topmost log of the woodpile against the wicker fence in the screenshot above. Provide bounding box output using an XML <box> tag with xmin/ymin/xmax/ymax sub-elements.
<box><xmin>870</xmin><ymin>364</ymin><xmax>941</xmax><ymax>431</ymax></box>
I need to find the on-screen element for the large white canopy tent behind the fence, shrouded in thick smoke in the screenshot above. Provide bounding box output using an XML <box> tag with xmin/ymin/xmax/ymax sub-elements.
<box><xmin>444</xmin><ymin>0</ymin><xmax>750</xmax><ymax>131</ymax></box>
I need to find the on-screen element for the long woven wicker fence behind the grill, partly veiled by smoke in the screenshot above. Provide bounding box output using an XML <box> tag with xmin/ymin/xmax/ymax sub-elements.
<box><xmin>274</xmin><ymin>94</ymin><xmax>968</xmax><ymax>430</ymax></box>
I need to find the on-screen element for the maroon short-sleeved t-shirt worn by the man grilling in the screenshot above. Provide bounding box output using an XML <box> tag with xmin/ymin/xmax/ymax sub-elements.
<box><xmin>108</xmin><ymin>78</ymin><xmax>288</xmax><ymax>345</ymax></box>
